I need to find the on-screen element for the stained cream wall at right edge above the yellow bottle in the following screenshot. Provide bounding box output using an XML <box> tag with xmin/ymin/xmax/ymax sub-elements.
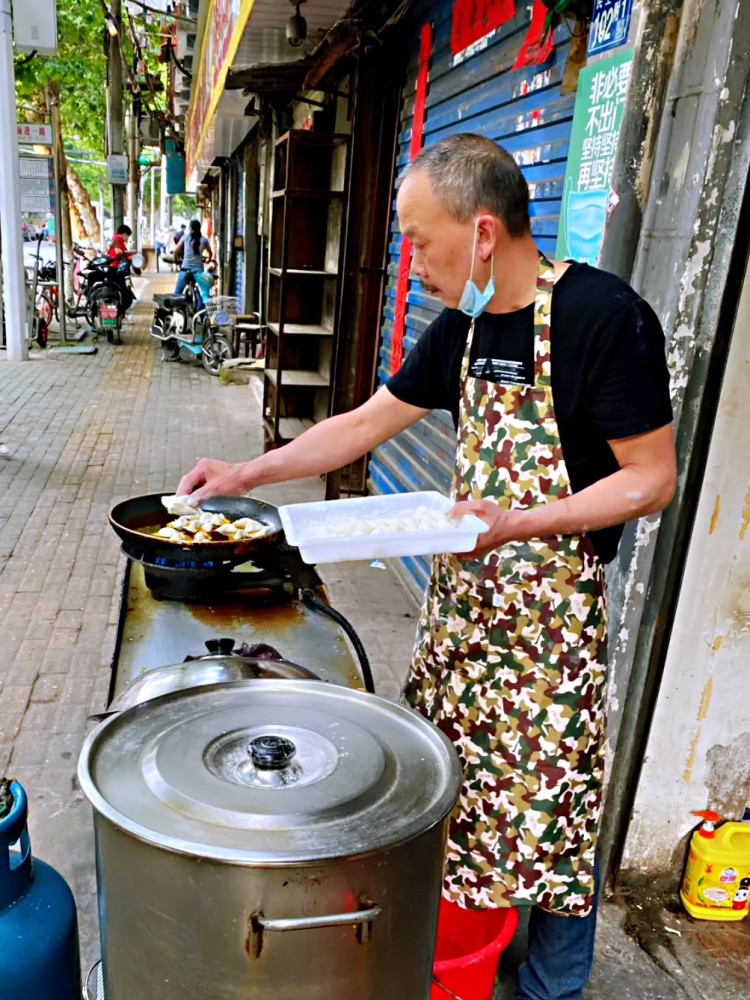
<box><xmin>624</xmin><ymin>250</ymin><xmax>750</xmax><ymax>872</ymax></box>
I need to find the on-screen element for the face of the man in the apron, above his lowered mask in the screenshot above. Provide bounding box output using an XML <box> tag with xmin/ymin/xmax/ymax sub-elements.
<box><xmin>396</xmin><ymin>170</ymin><xmax>476</xmax><ymax>309</ymax></box>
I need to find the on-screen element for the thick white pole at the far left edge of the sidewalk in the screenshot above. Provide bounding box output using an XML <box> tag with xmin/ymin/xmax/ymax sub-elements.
<box><xmin>0</xmin><ymin>0</ymin><xmax>28</xmax><ymax>361</ymax></box>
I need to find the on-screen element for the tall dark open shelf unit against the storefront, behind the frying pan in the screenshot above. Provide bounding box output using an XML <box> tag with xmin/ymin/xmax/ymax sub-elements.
<box><xmin>263</xmin><ymin>130</ymin><xmax>349</xmax><ymax>450</ymax></box>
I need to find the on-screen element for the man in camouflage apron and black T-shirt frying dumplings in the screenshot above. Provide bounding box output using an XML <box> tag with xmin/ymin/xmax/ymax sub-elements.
<box><xmin>178</xmin><ymin>135</ymin><xmax>676</xmax><ymax>1000</ymax></box>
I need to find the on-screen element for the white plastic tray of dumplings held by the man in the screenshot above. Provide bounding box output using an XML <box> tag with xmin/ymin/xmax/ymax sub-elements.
<box><xmin>279</xmin><ymin>490</ymin><xmax>488</xmax><ymax>563</ymax></box>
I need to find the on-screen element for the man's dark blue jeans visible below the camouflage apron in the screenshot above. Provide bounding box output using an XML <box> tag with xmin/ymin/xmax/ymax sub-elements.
<box><xmin>513</xmin><ymin>857</ymin><xmax>600</xmax><ymax>1000</ymax></box>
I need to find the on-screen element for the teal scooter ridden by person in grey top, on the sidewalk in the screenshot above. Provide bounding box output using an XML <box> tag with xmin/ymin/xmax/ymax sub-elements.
<box><xmin>150</xmin><ymin>271</ymin><xmax>237</xmax><ymax>375</ymax></box>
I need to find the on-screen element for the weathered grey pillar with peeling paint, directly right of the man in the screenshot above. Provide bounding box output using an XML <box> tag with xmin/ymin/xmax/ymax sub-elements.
<box><xmin>602</xmin><ymin>0</ymin><xmax>750</xmax><ymax>866</ymax></box>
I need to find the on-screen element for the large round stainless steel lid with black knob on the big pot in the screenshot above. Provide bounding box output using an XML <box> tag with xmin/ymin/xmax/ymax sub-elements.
<box><xmin>78</xmin><ymin>679</ymin><xmax>461</xmax><ymax>865</ymax></box>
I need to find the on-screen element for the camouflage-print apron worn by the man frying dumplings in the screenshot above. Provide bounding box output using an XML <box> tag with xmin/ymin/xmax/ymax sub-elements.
<box><xmin>404</xmin><ymin>258</ymin><xmax>606</xmax><ymax>916</ymax></box>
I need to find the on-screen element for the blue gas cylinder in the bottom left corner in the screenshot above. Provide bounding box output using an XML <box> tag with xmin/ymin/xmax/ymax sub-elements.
<box><xmin>0</xmin><ymin>781</ymin><xmax>81</xmax><ymax>1000</ymax></box>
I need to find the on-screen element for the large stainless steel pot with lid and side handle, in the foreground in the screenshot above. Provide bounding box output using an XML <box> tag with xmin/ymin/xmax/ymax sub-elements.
<box><xmin>79</xmin><ymin>680</ymin><xmax>460</xmax><ymax>1000</ymax></box>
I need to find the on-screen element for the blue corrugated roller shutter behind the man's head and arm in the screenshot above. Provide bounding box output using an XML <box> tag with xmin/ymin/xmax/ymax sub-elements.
<box><xmin>370</xmin><ymin>0</ymin><xmax>575</xmax><ymax>593</ymax></box>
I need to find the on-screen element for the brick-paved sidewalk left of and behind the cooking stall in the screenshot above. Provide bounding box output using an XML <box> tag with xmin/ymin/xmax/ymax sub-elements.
<box><xmin>0</xmin><ymin>275</ymin><xmax>414</xmax><ymax>968</ymax></box>
